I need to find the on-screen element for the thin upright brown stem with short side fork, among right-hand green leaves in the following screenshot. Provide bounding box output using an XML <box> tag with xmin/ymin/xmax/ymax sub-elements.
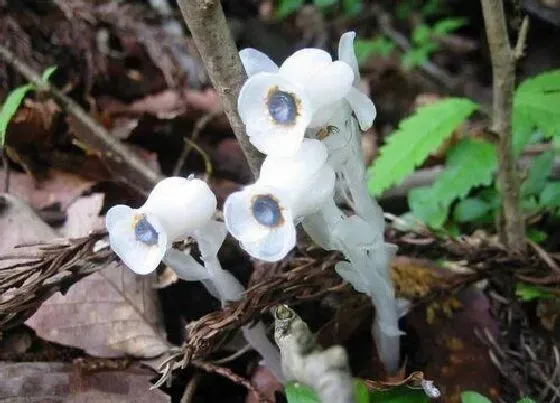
<box><xmin>481</xmin><ymin>0</ymin><xmax>527</xmax><ymax>254</ymax></box>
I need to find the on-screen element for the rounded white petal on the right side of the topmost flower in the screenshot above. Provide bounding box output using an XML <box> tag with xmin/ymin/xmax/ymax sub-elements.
<box><xmin>305</xmin><ymin>61</ymin><xmax>354</xmax><ymax>110</ymax></box>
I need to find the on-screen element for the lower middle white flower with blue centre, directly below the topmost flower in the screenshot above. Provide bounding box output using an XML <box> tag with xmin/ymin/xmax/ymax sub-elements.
<box><xmin>224</xmin><ymin>139</ymin><xmax>335</xmax><ymax>261</ymax></box>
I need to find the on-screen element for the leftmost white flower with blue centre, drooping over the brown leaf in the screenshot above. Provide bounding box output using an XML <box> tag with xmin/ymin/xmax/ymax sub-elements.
<box><xmin>105</xmin><ymin>177</ymin><xmax>216</xmax><ymax>274</ymax></box>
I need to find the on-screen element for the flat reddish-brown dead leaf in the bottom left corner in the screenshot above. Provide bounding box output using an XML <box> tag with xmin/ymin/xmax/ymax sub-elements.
<box><xmin>0</xmin><ymin>362</ymin><xmax>171</xmax><ymax>403</ymax></box>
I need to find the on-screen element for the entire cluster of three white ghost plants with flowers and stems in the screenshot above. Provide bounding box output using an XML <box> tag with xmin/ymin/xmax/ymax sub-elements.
<box><xmin>106</xmin><ymin>32</ymin><xmax>399</xmax><ymax>374</ymax></box>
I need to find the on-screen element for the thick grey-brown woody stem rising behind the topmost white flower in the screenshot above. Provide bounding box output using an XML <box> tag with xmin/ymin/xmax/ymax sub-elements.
<box><xmin>177</xmin><ymin>0</ymin><xmax>263</xmax><ymax>178</ymax></box>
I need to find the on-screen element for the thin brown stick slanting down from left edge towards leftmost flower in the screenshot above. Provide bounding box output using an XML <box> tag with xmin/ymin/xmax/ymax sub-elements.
<box><xmin>0</xmin><ymin>44</ymin><xmax>159</xmax><ymax>191</ymax></box>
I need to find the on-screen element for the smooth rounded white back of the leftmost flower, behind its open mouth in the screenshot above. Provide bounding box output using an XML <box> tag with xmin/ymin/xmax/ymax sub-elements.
<box><xmin>139</xmin><ymin>176</ymin><xmax>217</xmax><ymax>241</ymax></box>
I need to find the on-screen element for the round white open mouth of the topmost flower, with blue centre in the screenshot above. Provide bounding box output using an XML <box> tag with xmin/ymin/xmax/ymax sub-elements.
<box><xmin>237</xmin><ymin>73</ymin><xmax>312</xmax><ymax>155</ymax></box>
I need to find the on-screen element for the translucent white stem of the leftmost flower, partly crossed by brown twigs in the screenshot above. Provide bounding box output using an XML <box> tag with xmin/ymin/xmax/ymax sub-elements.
<box><xmin>164</xmin><ymin>221</ymin><xmax>284</xmax><ymax>382</ymax></box>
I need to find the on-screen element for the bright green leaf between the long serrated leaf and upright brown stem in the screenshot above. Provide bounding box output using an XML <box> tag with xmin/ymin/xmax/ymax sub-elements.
<box><xmin>433</xmin><ymin>138</ymin><xmax>498</xmax><ymax>204</ymax></box>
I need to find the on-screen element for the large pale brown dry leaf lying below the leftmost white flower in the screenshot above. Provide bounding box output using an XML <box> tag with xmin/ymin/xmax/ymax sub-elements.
<box><xmin>26</xmin><ymin>264</ymin><xmax>168</xmax><ymax>358</ymax></box>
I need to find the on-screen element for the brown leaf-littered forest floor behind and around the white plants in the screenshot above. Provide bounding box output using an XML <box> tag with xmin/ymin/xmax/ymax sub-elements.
<box><xmin>0</xmin><ymin>0</ymin><xmax>560</xmax><ymax>402</ymax></box>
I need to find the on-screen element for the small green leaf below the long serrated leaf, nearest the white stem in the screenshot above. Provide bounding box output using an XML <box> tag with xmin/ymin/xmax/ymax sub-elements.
<box><xmin>408</xmin><ymin>186</ymin><xmax>447</xmax><ymax>229</ymax></box>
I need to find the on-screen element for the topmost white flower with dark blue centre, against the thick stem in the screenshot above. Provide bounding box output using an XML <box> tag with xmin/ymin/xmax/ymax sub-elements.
<box><xmin>238</xmin><ymin>49</ymin><xmax>354</xmax><ymax>156</ymax></box>
